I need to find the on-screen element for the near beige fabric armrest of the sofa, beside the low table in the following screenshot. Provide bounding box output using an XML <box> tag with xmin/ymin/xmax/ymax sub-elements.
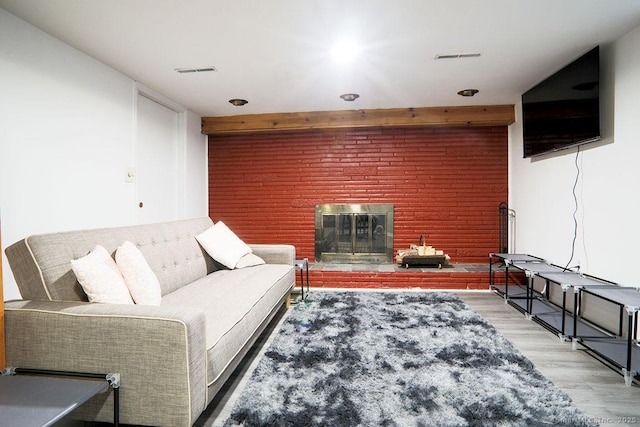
<box><xmin>5</xmin><ymin>300</ymin><xmax>207</xmax><ymax>426</ymax></box>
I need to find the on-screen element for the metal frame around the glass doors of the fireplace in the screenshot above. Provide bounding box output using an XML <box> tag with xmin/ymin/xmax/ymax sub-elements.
<box><xmin>315</xmin><ymin>204</ymin><xmax>394</xmax><ymax>264</ymax></box>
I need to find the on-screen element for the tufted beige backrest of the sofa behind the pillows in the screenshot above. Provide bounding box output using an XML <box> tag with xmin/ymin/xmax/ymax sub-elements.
<box><xmin>5</xmin><ymin>217</ymin><xmax>216</xmax><ymax>301</ymax></box>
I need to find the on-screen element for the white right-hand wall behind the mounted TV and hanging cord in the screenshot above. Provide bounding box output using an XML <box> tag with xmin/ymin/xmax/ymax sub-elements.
<box><xmin>509</xmin><ymin>27</ymin><xmax>640</xmax><ymax>286</ymax></box>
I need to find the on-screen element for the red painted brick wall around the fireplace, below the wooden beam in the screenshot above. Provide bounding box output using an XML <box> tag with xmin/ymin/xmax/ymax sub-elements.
<box><xmin>209</xmin><ymin>127</ymin><xmax>508</xmax><ymax>263</ymax></box>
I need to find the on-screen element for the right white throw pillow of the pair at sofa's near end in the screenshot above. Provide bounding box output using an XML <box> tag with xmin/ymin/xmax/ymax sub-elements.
<box><xmin>116</xmin><ymin>241</ymin><xmax>162</xmax><ymax>305</ymax></box>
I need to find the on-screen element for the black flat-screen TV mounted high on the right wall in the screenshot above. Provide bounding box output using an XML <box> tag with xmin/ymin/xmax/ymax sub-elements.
<box><xmin>522</xmin><ymin>47</ymin><xmax>601</xmax><ymax>157</ymax></box>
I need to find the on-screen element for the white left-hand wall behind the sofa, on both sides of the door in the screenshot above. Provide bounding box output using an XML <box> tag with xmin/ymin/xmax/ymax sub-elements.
<box><xmin>0</xmin><ymin>9</ymin><xmax>208</xmax><ymax>299</ymax></box>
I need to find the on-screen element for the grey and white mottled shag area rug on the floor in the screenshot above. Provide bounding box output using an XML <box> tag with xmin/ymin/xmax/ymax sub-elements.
<box><xmin>225</xmin><ymin>292</ymin><xmax>598</xmax><ymax>427</ymax></box>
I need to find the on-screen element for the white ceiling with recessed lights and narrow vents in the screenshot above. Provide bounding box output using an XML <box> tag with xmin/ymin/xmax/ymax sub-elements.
<box><xmin>0</xmin><ymin>0</ymin><xmax>640</xmax><ymax>116</ymax></box>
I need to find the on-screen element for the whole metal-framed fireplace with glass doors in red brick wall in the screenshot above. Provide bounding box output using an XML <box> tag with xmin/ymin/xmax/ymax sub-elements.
<box><xmin>315</xmin><ymin>204</ymin><xmax>393</xmax><ymax>264</ymax></box>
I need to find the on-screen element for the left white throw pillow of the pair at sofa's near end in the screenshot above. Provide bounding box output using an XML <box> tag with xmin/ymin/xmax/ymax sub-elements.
<box><xmin>71</xmin><ymin>245</ymin><xmax>133</xmax><ymax>304</ymax></box>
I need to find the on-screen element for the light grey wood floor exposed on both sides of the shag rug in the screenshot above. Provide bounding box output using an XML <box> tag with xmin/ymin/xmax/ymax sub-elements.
<box><xmin>195</xmin><ymin>291</ymin><xmax>640</xmax><ymax>426</ymax></box>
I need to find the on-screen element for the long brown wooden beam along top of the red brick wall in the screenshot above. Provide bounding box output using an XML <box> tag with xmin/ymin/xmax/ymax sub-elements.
<box><xmin>202</xmin><ymin>105</ymin><xmax>515</xmax><ymax>135</ymax></box>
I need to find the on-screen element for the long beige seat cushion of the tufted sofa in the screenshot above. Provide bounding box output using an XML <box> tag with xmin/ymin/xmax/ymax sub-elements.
<box><xmin>162</xmin><ymin>264</ymin><xmax>295</xmax><ymax>384</ymax></box>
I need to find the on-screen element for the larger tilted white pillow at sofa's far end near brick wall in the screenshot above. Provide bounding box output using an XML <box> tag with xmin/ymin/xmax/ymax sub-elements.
<box><xmin>196</xmin><ymin>221</ymin><xmax>251</xmax><ymax>268</ymax></box>
